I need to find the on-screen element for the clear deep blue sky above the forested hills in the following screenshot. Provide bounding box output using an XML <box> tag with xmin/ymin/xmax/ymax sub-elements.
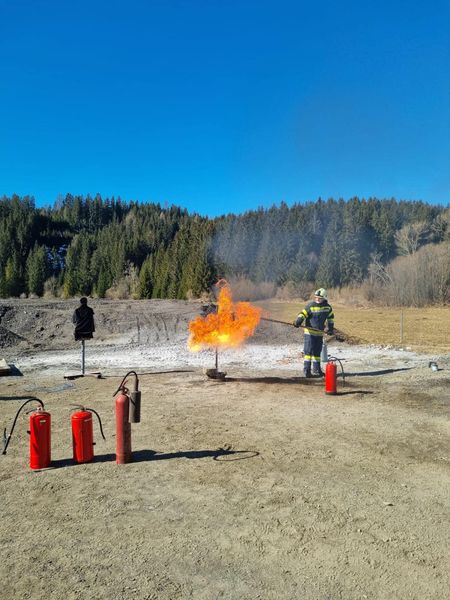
<box><xmin>0</xmin><ymin>0</ymin><xmax>450</xmax><ymax>215</ymax></box>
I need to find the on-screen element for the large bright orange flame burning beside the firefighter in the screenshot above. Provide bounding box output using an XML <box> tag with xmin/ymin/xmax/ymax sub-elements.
<box><xmin>188</xmin><ymin>285</ymin><xmax>262</xmax><ymax>352</ymax></box>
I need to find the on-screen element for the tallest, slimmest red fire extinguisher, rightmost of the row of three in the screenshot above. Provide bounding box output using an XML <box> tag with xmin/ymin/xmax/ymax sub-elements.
<box><xmin>113</xmin><ymin>371</ymin><xmax>141</xmax><ymax>465</ymax></box>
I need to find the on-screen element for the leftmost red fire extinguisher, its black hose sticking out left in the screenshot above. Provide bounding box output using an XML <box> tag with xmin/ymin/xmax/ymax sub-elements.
<box><xmin>3</xmin><ymin>398</ymin><xmax>51</xmax><ymax>469</ymax></box>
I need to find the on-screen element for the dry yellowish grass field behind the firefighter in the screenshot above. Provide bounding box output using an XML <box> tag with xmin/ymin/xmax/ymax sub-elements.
<box><xmin>258</xmin><ymin>299</ymin><xmax>450</xmax><ymax>353</ymax></box>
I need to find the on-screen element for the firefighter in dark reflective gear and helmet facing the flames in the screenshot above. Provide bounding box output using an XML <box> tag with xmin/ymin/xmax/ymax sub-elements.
<box><xmin>294</xmin><ymin>288</ymin><xmax>334</xmax><ymax>377</ymax></box>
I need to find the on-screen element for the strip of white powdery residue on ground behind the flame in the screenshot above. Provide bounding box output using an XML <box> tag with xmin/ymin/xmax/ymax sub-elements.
<box><xmin>8</xmin><ymin>341</ymin><xmax>449</xmax><ymax>375</ymax></box>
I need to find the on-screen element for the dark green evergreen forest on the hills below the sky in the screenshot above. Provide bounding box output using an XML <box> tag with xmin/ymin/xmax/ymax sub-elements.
<box><xmin>0</xmin><ymin>194</ymin><xmax>450</xmax><ymax>298</ymax></box>
